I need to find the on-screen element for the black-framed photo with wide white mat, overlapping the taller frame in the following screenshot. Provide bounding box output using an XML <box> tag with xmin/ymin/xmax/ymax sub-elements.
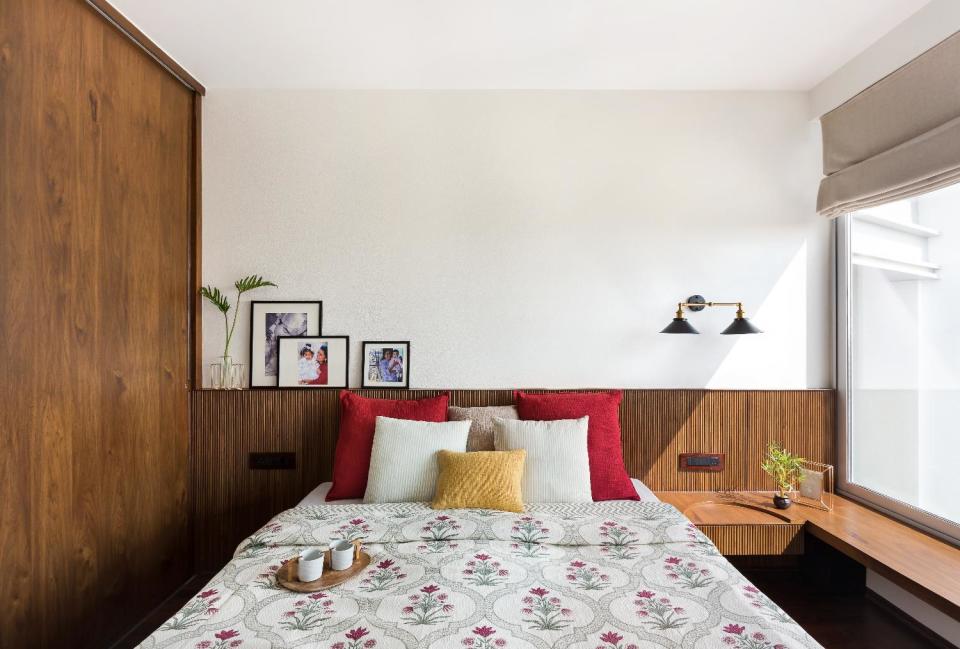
<box><xmin>277</xmin><ymin>336</ymin><xmax>350</xmax><ymax>388</ymax></box>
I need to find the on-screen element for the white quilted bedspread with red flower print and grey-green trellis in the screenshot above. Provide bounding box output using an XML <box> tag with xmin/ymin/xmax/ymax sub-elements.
<box><xmin>141</xmin><ymin>501</ymin><xmax>820</xmax><ymax>649</ymax></box>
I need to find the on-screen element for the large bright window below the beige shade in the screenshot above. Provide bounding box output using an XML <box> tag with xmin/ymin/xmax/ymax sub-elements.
<box><xmin>837</xmin><ymin>180</ymin><xmax>960</xmax><ymax>540</ymax></box>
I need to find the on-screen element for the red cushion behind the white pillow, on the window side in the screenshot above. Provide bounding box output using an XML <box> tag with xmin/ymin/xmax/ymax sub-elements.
<box><xmin>514</xmin><ymin>390</ymin><xmax>640</xmax><ymax>501</ymax></box>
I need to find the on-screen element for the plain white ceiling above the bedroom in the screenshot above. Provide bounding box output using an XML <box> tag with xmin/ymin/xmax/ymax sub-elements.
<box><xmin>113</xmin><ymin>0</ymin><xmax>928</xmax><ymax>90</ymax></box>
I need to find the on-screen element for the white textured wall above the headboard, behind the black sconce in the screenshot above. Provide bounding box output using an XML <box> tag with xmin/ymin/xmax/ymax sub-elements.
<box><xmin>203</xmin><ymin>90</ymin><xmax>833</xmax><ymax>388</ymax></box>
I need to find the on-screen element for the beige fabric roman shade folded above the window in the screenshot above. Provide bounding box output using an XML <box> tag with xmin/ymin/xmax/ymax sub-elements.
<box><xmin>817</xmin><ymin>32</ymin><xmax>960</xmax><ymax>217</ymax></box>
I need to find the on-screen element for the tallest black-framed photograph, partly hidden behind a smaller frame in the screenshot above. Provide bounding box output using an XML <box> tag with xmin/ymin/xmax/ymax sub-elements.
<box><xmin>250</xmin><ymin>301</ymin><xmax>323</xmax><ymax>388</ymax></box>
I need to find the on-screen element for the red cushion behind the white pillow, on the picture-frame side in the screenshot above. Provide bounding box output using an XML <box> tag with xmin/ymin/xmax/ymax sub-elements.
<box><xmin>327</xmin><ymin>390</ymin><xmax>450</xmax><ymax>500</ymax></box>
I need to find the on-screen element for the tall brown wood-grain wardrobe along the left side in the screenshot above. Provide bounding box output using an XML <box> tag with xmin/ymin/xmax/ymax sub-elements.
<box><xmin>0</xmin><ymin>0</ymin><xmax>202</xmax><ymax>649</ymax></box>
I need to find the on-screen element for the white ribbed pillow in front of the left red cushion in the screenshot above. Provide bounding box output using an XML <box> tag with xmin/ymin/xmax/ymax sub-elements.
<box><xmin>363</xmin><ymin>417</ymin><xmax>470</xmax><ymax>503</ymax></box>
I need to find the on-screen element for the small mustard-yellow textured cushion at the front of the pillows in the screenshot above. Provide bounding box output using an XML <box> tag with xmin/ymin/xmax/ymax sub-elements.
<box><xmin>431</xmin><ymin>449</ymin><xmax>527</xmax><ymax>512</ymax></box>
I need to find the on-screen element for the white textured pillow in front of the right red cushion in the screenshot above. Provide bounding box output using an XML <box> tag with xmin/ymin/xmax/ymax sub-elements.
<box><xmin>493</xmin><ymin>417</ymin><xmax>593</xmax><ymax>503</ymax></box>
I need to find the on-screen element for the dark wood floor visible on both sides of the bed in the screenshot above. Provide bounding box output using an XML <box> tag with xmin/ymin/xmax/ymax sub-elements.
<box><xmin>113</xmin><ymin>543</ymin><xmax>950</xmax><ymax>649</ymax></box>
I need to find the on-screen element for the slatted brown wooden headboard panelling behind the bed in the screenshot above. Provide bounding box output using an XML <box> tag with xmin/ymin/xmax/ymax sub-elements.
<box><xmin>192</xmin><ymin>389</ymin><xmax>836</xmax><ymax>570</ymax></box>
